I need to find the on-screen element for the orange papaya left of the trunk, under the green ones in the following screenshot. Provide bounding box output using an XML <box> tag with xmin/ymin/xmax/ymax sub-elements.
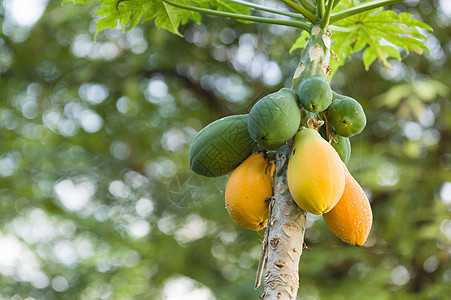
<box><xmin>225</xmin><ymin>152</ymin><xmax>275</xmax><ymax>230</ymax></box>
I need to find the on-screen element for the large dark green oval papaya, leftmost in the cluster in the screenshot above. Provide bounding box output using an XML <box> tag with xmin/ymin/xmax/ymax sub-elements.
<box><xmin>189</xmin><ymin>114</ymin><xmax>255</xmax><ymax>177</ymax></box>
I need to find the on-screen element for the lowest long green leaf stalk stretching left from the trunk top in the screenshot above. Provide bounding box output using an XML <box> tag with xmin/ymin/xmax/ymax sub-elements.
<box><xmin>163</xmin><ymin>0</ymin><xmax>311</xmax><ymax>31</ymax></box>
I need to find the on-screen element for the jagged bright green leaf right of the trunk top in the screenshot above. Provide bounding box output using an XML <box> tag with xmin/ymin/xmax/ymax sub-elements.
<box><xmin>331</xmin><ymin>4</ymin><xmax>432</xmax><ymax>72</ymax></box>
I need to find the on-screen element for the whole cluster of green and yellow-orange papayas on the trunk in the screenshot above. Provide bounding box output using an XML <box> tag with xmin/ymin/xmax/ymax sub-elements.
<box><xmin>189</xmin><ymin>73</ymin><xmax>372</xmax><ymax>245</ymax></box>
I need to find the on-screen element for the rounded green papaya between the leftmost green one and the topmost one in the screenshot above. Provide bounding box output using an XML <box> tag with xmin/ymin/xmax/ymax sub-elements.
<box><xmin>248</xmin><ymin>88</ymin><xmax>301</xmax><ymax>150</ymax></box>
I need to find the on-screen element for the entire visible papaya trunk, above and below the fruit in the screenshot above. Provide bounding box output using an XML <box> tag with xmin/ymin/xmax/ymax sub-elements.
<box><xmin>261</xmin><ymin>26</ymin><xmax>331</xmax><ymax>300</ymax></box>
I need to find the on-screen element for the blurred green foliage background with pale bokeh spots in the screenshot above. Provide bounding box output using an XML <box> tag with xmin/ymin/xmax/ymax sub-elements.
<box><xmin>0</xmin><ymin>0</ymin><xmax>451</xmax><ymax>300</ymax></box>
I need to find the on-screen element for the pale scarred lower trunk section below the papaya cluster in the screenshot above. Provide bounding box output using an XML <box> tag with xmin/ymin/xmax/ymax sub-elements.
<box><xmin>261</xmin><ymin>146</ymin><xmax>306</xmax><ymax>299</ymax></box>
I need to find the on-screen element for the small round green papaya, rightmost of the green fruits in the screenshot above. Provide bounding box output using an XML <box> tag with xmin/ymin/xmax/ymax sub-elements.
<box><xmin>328</xmin><ymin>95</ymin><xmax>366</xmax><ymax>137</ymax></box>
